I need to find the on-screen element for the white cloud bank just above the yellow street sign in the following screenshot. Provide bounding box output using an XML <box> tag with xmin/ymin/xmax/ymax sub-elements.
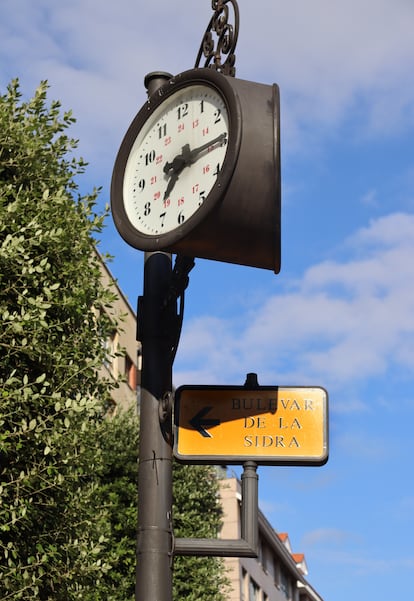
<box><xmin>177</xmin><ymin>214</ymin><xmax>414</xmax><ymax>387</ymax></box>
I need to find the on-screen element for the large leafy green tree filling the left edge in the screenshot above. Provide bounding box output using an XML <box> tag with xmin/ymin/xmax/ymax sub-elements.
<box><xmin>0</xmin><ymin>80</ymin><xmax>112</xmax><ymax>601</ymax></box>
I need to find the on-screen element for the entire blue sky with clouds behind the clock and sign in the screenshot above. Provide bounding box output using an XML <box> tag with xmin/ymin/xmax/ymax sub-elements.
<box><xmin>0</xmin><ymin>0</ymin><xmax>414</xmax><ymax>601</ymax></box>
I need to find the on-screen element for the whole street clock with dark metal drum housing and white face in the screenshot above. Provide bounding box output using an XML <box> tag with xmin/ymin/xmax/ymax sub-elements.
<box><xmin>111</xmin><ymin>68</ymin><xmax>281</xmax><ymax>273</ymax></box>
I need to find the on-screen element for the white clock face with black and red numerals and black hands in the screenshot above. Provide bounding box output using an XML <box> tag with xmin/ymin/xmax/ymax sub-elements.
<box><xmin>123</xmin><ymin>84</ymin><xmax>229</xmax><ymax>236</ymax></box>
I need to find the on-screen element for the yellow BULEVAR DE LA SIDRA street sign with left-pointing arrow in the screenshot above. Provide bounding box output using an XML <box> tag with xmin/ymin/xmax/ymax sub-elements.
<box><xmin>174</xmin><ymin>386</ymin><xmax>328</xmax><ymax>465</ymax></box>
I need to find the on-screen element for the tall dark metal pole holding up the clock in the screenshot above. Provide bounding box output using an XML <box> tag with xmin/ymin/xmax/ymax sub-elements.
<box><xmin>135</xmin><ymin>73</ymin><xmax>176</xmax><ymax>601</ymax></box>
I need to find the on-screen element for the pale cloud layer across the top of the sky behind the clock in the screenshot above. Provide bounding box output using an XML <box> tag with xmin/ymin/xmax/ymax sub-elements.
<box><xmin>0</xmin><ymin>0</ymin><xmax>414</xmax><ymax>167</ymax></box>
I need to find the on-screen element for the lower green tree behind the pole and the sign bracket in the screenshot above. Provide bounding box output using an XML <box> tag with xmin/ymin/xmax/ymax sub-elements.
<box><xmin>93</xmin><ymin>411</ymin><xmax>227</xmax><ymax>601</ymax></box>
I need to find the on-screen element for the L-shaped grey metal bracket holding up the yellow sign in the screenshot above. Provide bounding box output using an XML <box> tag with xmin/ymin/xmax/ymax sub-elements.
<box><xmin>173</xmin><ymin>461</ymin><xmax>259</xmax><ymax>558</ymax></box>
